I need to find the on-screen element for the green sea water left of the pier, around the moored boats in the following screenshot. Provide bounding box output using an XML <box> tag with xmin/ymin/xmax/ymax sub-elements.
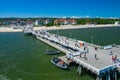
<box><xmin>0</xmin><ymin>32</ymin><xmax>93</xmax><ymax>80</ymax></box>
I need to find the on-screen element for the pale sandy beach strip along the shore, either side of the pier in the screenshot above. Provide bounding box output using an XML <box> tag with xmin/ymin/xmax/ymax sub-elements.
<box><xmin>0</xmin><ymin>24</ymin><xmax>120</xmax><ymax>32</ymax></box>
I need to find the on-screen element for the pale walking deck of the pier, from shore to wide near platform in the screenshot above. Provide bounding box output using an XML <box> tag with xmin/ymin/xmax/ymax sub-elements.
<box><xmin>37</xmin><ymin>30</ymin><xmax>120</xmax><ymax>74</ymax></box>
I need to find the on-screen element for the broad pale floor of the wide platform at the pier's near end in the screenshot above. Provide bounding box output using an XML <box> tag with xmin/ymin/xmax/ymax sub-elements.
<box><xmin>76</xmin><ymin>46</ymin><xmax>114</xmax><ymax>69</ymax></box>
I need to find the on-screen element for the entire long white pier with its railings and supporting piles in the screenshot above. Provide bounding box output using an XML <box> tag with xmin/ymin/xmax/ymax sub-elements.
<box><xmin>23</xmin><ymin>27</ymin><xmax>120</xmax><ymax>80</ymax></box>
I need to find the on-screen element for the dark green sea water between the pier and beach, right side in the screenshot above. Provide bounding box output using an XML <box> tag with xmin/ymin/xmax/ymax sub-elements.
<box><xmin>50</xmin><ymin>26</ymin><xmax>120</xmax><ymax>46</ymax></box>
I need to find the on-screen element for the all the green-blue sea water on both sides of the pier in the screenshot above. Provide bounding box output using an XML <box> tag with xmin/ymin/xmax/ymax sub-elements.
<box><xmin>0</xmin><ymin>27</ymin><xmax>120</xmax><ymax>80</ymax></box>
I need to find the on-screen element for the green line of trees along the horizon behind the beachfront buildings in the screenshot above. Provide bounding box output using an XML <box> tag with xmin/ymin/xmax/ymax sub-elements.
<box><xmin>0</xmin><ymin>18</ymin><xmax>120</xmax><ymax>26</ymax></box>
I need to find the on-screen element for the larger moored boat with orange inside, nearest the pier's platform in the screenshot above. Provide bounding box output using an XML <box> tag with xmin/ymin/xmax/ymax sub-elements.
<box><xmin>51</xmin><ymin>58</ymin><xmax>68</xmax><ymax>69</ymax></box>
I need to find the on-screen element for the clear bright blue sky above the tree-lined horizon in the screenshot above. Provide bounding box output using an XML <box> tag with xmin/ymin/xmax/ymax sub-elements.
<box><xmin>0</xmin><ymin>0</ymin><xmax>120</xmax><ymax>18</ymax></box>
